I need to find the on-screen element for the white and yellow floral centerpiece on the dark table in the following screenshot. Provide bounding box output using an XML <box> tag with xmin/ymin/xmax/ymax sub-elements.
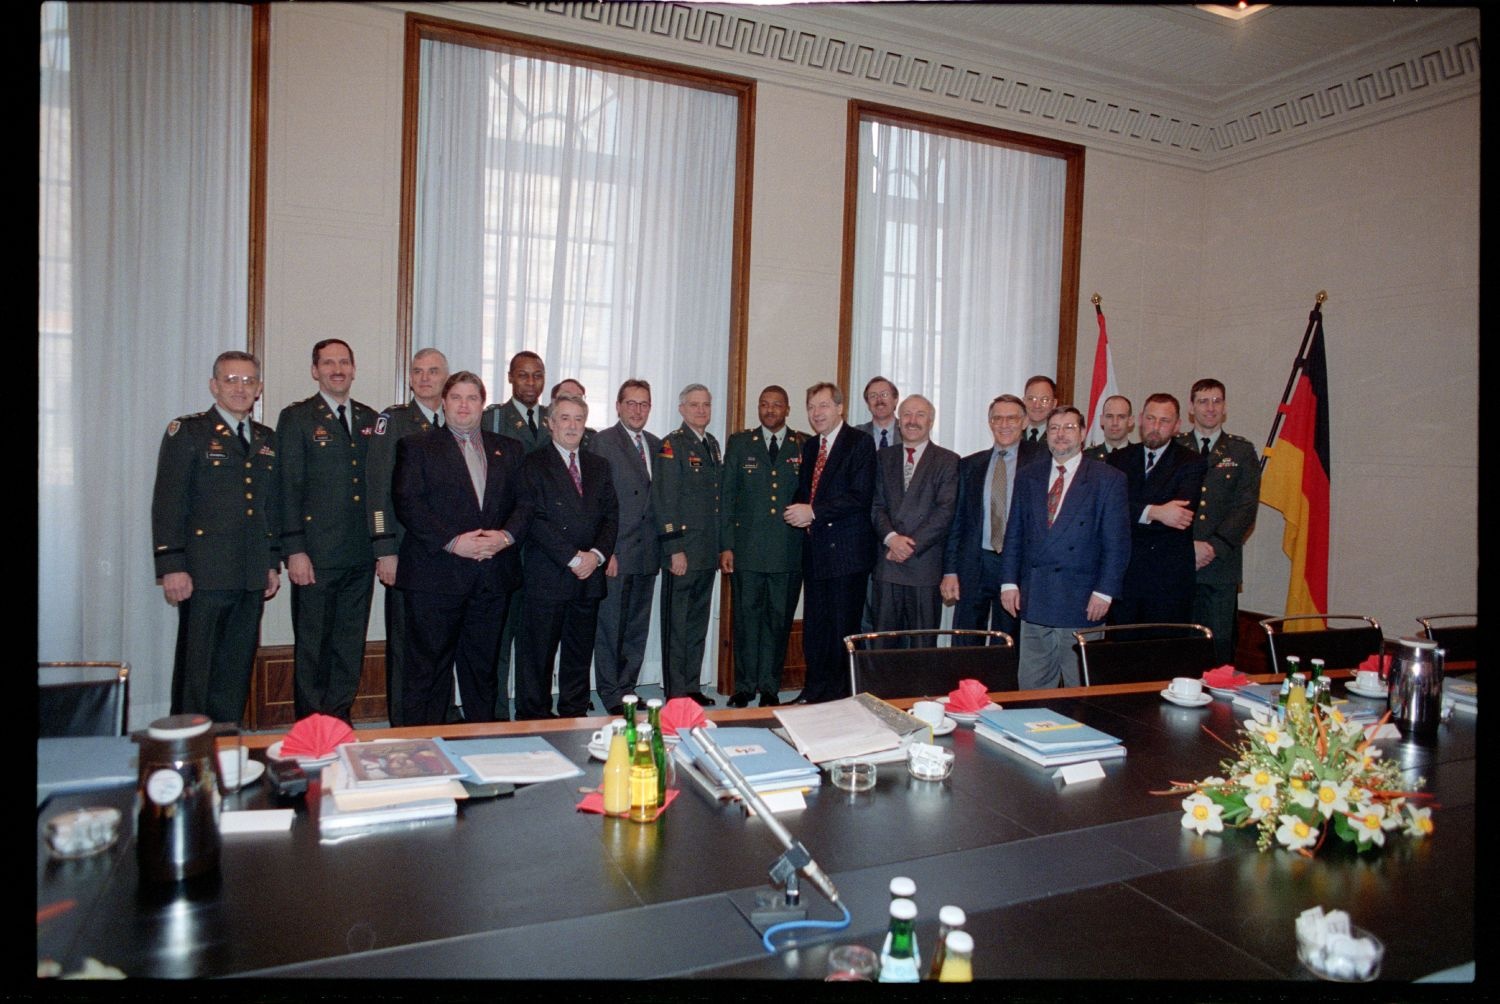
<box><xmin>1154</xmin><ymin>702</ymin><xmax>1433</xmax><ymax>857</ymax></box>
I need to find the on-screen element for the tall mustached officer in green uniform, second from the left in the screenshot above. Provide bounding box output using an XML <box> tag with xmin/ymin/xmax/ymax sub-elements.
<box><xmin>276</xmin><ymin>338</ymin><xmax>375</xmax><ymax>720</ymax></box>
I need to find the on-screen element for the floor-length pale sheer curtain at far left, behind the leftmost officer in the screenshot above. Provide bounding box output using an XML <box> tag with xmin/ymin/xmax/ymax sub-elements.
<box><xmin>38</xmin><ymin>3</ymin><xmax>252</xmax><ymax>728</ymax></box>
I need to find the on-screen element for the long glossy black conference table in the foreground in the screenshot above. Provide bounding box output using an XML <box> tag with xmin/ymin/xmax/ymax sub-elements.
<box><xmin>36</xmin><ymin>672</ymin><xmax>1476</xmax><ymax>980</ymax></box>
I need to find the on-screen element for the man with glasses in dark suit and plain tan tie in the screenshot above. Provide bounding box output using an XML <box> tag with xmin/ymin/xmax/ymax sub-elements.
<box><xmin>941</xmin><ymin>393</ymin><xmax>1047</xmax><ymax>645</ymax></box>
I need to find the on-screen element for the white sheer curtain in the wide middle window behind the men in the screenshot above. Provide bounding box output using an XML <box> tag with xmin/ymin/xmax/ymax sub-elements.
<box><xmin>413</xmin><ymin>41</ymin><xmax>738</xmax><ymax>683</ymax></box>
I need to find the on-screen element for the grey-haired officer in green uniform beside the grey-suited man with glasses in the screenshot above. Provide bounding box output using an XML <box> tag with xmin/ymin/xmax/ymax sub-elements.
<box><xmin>651</xmin><ymin>384</ymin><xmax>722</xmax><ymax>705</ymax></box>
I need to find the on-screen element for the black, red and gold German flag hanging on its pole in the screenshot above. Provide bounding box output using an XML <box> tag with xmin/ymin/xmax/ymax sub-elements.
<box><xmin>1260</xmin><ymin>306</ymin><xmax>1329</xmax><ymax>626</ymax></box>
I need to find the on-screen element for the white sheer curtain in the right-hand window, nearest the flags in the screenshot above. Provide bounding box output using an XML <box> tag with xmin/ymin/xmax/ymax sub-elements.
<box><xmin>849</xmin><ymin>119</ymin><xmax>1067</xmax><ymax>453</ymax></box>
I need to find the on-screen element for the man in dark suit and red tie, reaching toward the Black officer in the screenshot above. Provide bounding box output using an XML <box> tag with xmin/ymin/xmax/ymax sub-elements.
<box><xmin>783</xmin><ymin>383</ymin><xmax>876</xmax><ymax>704</ymax></box>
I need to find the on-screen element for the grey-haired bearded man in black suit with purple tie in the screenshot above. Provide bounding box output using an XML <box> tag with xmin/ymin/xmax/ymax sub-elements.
<box><xmin>516</xmin><ymin>395</ymin><xmax>620</xmax><ymax>720</ymax></box>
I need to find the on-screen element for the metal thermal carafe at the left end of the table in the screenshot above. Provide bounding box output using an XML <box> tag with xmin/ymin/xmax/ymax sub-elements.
<box><xmin>131</xmin><ymin>714</ymin><xmax>239</xmax><ymax>882</ymax></box>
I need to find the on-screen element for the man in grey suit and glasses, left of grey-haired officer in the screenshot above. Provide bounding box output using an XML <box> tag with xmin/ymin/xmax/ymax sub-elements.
<box><xmin>588</xmin><ymin>380</ymin><xmax>662</xmax><ymax>714</ymax></box>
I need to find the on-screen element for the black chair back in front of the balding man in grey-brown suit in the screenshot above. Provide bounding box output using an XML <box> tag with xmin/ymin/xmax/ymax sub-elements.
<box><xmin>845</xmin><ymin>629</ymin><xmax>1016</xmax><ymax>698</ymax></box>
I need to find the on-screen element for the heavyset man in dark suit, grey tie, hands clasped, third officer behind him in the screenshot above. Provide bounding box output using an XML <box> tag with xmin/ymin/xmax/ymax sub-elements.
<box><xmin>392</xmin><ymin>371</ymin><xmax>531</xmax><ymax>725</ymax></box>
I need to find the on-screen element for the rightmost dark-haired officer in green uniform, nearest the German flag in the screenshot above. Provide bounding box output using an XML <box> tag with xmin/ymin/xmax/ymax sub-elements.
<box><xmin>1178</xmin><ymin>378</ymin><xmax>1260</xmax><ymax>662</ymax></box>
